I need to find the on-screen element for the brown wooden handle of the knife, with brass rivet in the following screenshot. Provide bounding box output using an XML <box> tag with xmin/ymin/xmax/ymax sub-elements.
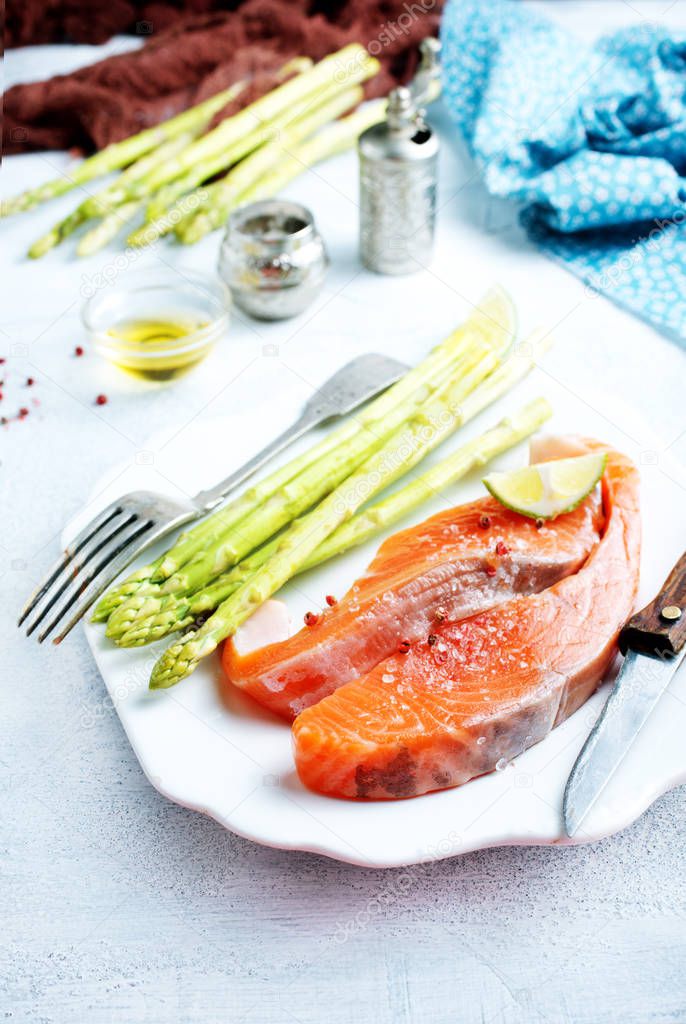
<box><xmin>619</xmin><ymin>552</ymin><xmax>686</xmax><ymax>654</ymax></box>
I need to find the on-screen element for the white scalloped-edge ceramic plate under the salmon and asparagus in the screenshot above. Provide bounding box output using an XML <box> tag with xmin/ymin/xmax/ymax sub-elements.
<box><xmin>81</xmin><ymin>371</ymin><xmax>686</xmax><ymax>867</ymax></box>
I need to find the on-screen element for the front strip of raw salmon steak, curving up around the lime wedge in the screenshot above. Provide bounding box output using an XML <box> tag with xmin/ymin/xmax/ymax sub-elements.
<box><xmin>293</xmin><ymin>441</ymin><xmax>640</xmax><ymax>800</ymax></box>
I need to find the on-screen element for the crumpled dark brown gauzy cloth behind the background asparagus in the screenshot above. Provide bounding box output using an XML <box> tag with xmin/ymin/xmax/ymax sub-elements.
<box><xmin>3</xmin><ymin>0</ymin><xmax>443</xmax><ymax>154</ymax></box>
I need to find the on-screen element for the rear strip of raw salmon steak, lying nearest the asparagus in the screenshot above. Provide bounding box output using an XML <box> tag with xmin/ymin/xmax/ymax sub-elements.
<box><xmin>223</xmin><ymin>490</ymin><xmax>603</xmax><ymax>720</ymax></box>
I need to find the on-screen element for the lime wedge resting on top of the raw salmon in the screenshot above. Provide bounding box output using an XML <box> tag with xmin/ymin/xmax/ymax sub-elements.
<box><xmin>483</xmin><ymin>454</ymin><xmax>606</xmax><ymax>519</ymax></box>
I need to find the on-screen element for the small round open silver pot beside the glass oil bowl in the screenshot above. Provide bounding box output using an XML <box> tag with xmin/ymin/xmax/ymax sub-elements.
<box><xmin>219</xmin><ymin>199</ymin><xmax>329</xmax><ymax>319</ymax></box>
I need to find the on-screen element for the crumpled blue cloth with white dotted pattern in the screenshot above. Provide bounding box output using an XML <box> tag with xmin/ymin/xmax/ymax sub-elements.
<box><xmin>441</xmin><ymin>0</ymin><xmax>686</xmax><ymax>345</ymax></box>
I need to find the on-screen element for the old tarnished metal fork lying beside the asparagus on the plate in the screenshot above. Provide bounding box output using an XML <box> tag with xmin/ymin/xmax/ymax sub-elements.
<box><xmin>17</xmin><ymin>354</ymin><xmax>409</xmax><ymax>643</ymax></box>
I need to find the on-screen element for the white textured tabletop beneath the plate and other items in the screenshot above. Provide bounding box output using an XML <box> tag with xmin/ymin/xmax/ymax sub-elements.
<box><xmin>0</xmin><ymin>0</ymin><xmax>686</xmax><ymax>1024</ymax></box>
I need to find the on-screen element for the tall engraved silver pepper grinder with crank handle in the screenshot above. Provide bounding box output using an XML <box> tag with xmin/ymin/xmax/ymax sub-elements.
<box><xmin>357</xmin><ymin>39</ymin><xmax>440</xmax><ymax>273</ymax></box>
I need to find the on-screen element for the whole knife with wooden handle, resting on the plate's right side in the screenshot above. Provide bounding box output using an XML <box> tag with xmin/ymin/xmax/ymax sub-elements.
<box><xmin>562</xmin><ymin>553</ymin><xmax>686</xmax><ymax>838</ymax></box>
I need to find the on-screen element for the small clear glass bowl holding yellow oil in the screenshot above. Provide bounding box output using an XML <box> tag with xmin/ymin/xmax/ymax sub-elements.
<box><xmin>81</xmin><ymin>269</ymin><xmax>231</xmax><ymax>382</ymax></box>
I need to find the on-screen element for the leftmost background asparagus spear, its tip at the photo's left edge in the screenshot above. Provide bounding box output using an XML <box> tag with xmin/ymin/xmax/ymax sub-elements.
<box><xmin>1</xmin><ymin>82</ymin><xmax>248</xmax><ymax>216</ymax></box>
